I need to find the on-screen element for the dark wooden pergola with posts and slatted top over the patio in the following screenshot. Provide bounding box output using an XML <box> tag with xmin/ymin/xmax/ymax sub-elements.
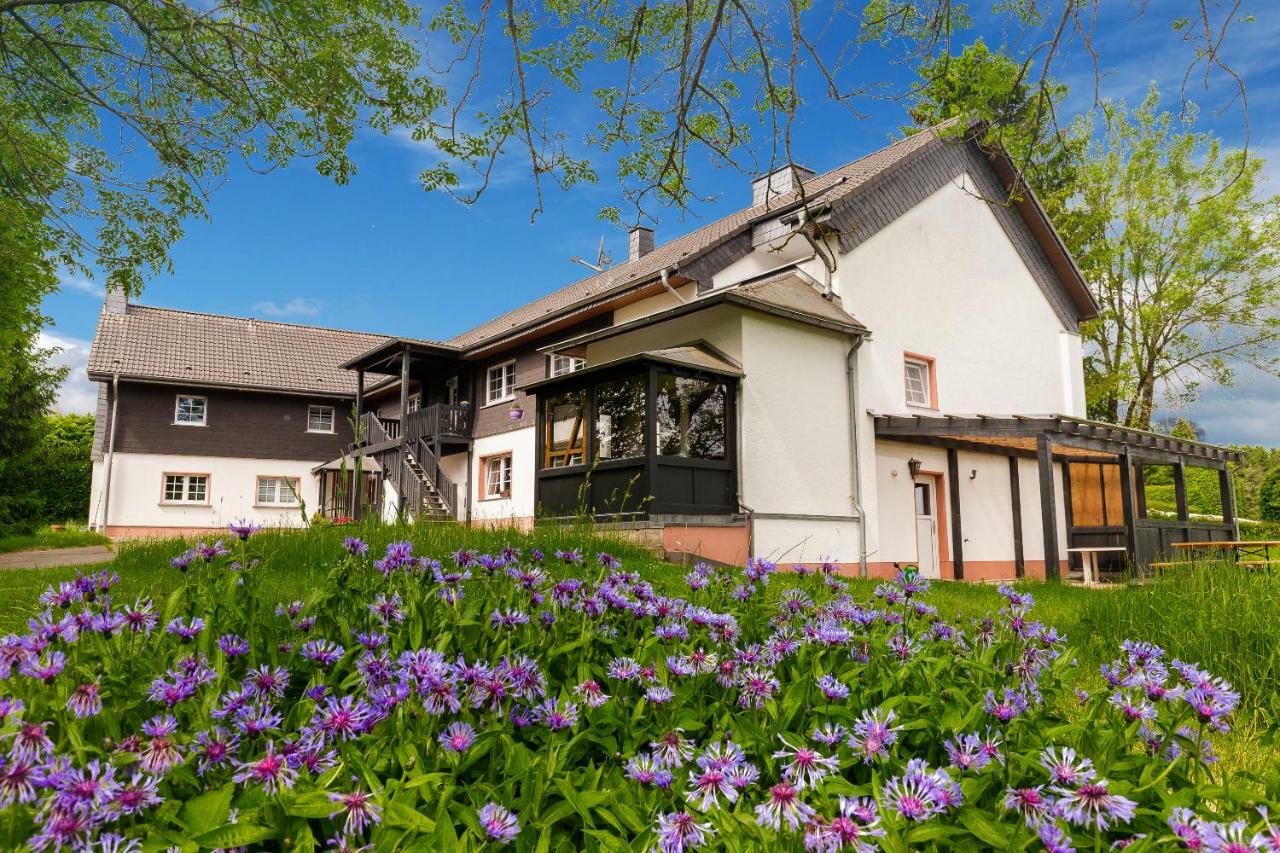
<box><xmin>874</xmin><ymin>415</ymin><xmax>1239</xmax><ymax>579</ymax></box>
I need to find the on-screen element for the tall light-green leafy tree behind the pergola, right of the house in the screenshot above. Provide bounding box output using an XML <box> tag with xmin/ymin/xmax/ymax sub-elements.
<box><xmin>1066</xmin><ymin>87</ymin><xmax>1280</xmax><ymax>429</ymax></box>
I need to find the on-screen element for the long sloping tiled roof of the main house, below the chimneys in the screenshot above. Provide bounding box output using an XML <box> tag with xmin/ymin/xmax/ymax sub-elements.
<box><xmin>448</xmin><ymin>119</ymin><xmax>956</xmax><ymax>347</ymax></box>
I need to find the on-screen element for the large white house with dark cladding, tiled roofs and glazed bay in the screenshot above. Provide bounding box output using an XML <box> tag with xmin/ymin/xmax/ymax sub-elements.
<box><xmin>82</xmin><ymin>126</ymin><xmax>1234</xmax><ymax>579</ymax></box>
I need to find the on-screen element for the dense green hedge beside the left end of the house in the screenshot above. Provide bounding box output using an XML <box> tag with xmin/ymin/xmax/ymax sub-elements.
<box><xmin>33</xmin><ymin>415</ymin><xmax>93</xmax><ymax>523</ymax></box>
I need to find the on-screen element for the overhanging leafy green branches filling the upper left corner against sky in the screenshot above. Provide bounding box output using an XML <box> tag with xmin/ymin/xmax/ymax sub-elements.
<box><xmin>0</xmin><ymin>0</ymin><xmax>442</xmax><ymax>292</ymax></box>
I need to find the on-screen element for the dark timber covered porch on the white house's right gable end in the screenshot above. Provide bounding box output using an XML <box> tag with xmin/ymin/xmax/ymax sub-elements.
<box><xmin>874</xmin><ymin>415</ymin><xmax>1238</xmax><ymax>580</ymax></box>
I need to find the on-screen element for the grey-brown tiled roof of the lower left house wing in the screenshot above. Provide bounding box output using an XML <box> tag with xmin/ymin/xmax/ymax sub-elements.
<box><xmin>88</xmin><ymin>305</ymin><xmax>390</xmax><ymax>397</ymax></box>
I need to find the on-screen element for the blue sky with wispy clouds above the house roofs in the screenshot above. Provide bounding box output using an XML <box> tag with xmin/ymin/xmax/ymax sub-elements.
<box><xmin>45</xmin><ymin>0</ymin><xmax>1280</xmax><ymax>444</ymax></box>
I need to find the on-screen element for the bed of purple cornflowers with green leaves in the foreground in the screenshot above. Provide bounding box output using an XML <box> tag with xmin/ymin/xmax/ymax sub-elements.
<box><xmin>0</xmin><ymin>525</ymin><xmax>1271</xmax><ymax>850</ymax></box>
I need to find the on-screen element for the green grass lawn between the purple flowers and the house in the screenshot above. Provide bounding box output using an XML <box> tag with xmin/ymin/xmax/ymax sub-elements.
<box><xmin>0</xmin><ymin>524</ymin><xmax>1280</xmax><ymax>771</ymax></box>
